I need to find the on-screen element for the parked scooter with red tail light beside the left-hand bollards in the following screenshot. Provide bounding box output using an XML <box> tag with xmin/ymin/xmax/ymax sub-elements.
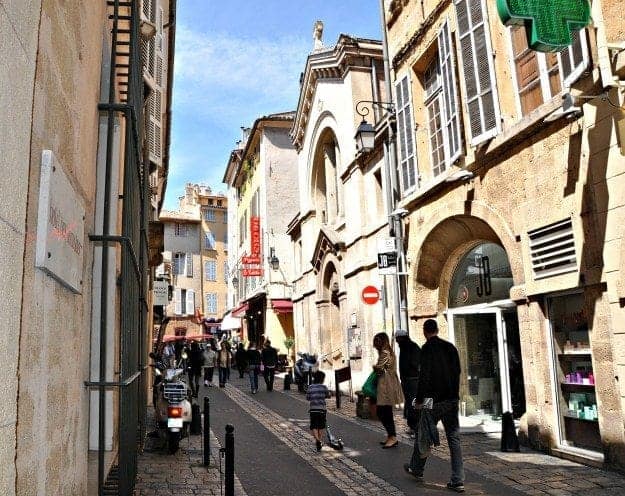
<box><xmin>150</xmin><ymin>353</ymin><xmax>192</xmax><ymax>454</ymax></box>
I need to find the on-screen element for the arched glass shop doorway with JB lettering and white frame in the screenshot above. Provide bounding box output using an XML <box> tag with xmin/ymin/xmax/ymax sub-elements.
<box><xmin>447</xmin><ymin>242</ymin><xmax>525</xmax><ymax>423</ymax></box>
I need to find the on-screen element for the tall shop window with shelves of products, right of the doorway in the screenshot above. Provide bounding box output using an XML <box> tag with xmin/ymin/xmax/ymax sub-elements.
<box><xmin>549</xmin><ymin>294</ymin><xmax>601</xmax><ymax>451</ymax></box>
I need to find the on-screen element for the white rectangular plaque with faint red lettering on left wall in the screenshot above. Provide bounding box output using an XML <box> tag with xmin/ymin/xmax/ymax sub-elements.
<box><xmin>35</xmin><ymin>150</ymin><xmax>85</xmax><ymax>293</ymax></box>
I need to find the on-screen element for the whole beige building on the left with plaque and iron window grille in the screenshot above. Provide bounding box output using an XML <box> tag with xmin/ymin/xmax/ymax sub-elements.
<box><xmin>0</xmin><ymin>0</ymin><xmax>175</xmax><ymax>496</ymax></box>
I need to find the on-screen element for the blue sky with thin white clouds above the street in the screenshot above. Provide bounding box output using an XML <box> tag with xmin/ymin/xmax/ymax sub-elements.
<box><xmin>164</xmin><ymin>0</ymin><xmax>381</xmax><ymax>209</ymax></box>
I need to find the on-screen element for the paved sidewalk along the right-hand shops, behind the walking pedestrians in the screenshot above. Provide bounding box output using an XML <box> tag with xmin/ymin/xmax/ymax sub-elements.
<box><xmin>276</xmin><ymin>381</ymin><xmax>625</xmax><ymax>496</ymax></box>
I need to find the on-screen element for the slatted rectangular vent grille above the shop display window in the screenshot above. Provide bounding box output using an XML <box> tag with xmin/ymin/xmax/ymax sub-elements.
<box><xmin>527</xmin><ymin>219</ymin><xmax>577</xmax><ymax>279</ymax></box>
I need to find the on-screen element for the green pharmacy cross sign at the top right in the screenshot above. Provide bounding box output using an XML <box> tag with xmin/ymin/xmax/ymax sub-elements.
<box><xmin>497</xmin><ymin>0</ymin><xmax>590</xmax><ymax>52</ymax></box>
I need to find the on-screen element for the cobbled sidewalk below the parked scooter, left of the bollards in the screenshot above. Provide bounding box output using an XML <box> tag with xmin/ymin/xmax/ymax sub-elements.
<box><xmin>134</xmin><ymin>414</ymin><xmax>247</xmax><ymax>496</ymax></box>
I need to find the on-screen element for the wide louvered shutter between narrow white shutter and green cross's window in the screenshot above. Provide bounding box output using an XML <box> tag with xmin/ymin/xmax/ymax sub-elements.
<box><xmin>454</xmin><ymin>0</ymin><xmax>501</xmax><ymax>146</ymax></box>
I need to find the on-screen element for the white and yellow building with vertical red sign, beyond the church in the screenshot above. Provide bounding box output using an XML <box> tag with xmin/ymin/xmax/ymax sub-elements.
<box><xmin>223</xmin><ymin>112</ymin><xmax>298</xmax><ymax>354</ymax></box>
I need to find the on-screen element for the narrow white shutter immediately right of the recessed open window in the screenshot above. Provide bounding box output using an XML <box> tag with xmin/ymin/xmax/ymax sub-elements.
<box><xmin>438</xmin><ymin>21</ymin><xmax>461</xmax><ymax>166</ymax></box>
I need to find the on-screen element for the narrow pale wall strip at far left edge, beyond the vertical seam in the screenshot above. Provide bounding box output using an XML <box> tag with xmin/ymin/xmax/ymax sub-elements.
<box><xmin>0</xmin><ymin>0</ymin><xmax>41</xmax><ymax>496</ymax></box>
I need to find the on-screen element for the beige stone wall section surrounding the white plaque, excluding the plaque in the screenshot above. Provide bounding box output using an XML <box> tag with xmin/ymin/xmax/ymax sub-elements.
<box><xmin>9</xmin><ymin>0</ymin><xmax>105</xmax><ymax>495</ymax></box>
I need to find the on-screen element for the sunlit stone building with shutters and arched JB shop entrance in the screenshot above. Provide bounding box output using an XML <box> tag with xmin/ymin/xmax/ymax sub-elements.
<box><xmin>385</xmin><ymin>0</ymin><xmax>625</xmax><ymax>470</ymax></box>
